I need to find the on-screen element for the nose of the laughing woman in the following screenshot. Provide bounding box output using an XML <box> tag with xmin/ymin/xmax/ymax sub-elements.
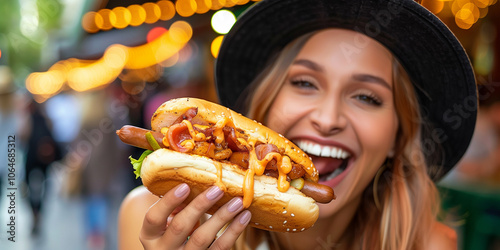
<box><xmin>310</xmin><ymin>98</ymin><xmax>347</xmax><ymax>136</ymax></box>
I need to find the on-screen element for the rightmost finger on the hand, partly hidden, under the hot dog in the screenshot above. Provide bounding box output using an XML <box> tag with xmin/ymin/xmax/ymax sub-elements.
<box><xmin>209</xmin><ymin>210</ymin><xmax>252</xmax><ymax>250</ymax></box>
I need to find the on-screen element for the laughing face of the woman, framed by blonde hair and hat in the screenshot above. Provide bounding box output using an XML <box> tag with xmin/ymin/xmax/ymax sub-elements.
<box><xmin>267</xmin><ymin>29</ymin><xmax>398</xmax><ymax>217</ymax></box>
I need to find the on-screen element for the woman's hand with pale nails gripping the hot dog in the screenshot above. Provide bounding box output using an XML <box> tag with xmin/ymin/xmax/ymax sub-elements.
<box><xmin>140</xmin><ymin>184</ymin><xmax>251</xmax><ymax>250</ymax></box>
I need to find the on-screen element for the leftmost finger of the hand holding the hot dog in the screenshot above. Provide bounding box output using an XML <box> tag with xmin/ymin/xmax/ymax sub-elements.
<box><xmin>140</xmin><ymin>183</ymin><xmax>189</xmax><ymax>240</ymax></box>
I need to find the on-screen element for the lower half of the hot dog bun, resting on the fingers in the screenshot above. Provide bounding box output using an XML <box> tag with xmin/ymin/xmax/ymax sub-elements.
<box><xmin>141</xmin><ymin>149</ymin><xmax>319</xmax><ymax>232</ymax></box>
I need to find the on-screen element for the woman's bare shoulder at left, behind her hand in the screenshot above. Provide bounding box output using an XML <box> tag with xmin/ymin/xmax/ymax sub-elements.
<box><xmin>118</xmin><ymin>186</ymin><xmax>159</xmax><ymax>250</ymax></box>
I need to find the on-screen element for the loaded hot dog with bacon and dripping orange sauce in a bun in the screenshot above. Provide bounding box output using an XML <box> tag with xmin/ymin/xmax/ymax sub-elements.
<box><xmin>117</xmin><ymin>98</ymin><xmax>335</xmax><ymax>232</ymax></box>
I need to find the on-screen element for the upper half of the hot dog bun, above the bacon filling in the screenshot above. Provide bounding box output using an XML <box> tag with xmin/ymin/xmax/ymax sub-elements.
<box><xmin>151</xmin><ymin>98</ymin><xmax>319</xmax><ymax>182</ymax></box>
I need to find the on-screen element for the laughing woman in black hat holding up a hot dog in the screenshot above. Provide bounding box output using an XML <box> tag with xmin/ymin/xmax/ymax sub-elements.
<box><xmin>120</xmin><ymin>0</ymin><xmax>477</xmax><ymax>249</ymax></box>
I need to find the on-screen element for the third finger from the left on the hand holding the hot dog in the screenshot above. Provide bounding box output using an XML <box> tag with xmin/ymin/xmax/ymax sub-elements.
<box><xmin>186</xmin><ymin>197</ymin><xmax>243</xmax><ymax>249</ymax></box>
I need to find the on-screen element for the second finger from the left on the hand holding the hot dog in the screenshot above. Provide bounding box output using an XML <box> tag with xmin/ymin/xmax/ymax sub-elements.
<box><xmin>164</xmin><ymin>186</ymin><xmax>224</xmax><ymax>246</ymax></box>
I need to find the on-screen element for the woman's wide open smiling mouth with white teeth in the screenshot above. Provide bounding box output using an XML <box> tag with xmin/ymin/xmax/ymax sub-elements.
<box><xmin>295</xmin><ymin>141</ymin><xmax>351</xmax><ymax>182</ymax></box>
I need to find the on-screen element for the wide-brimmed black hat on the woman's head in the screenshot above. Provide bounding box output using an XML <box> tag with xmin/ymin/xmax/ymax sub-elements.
<box><xmin>215</xmin><ymin>0</ymin><xmax>477</xmax><ymax>181</ymax></box>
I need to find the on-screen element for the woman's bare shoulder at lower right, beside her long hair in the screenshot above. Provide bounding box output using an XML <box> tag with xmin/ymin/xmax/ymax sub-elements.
<box><xmin>426</xmin><ymin>222</ymin><xmax>458</xmax><ymax>250</ymax></box>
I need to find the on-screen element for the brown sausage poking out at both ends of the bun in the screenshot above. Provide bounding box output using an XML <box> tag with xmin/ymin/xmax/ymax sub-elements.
<box><xmin>116</xmin><ymin>125</ymin><xmax>335</xmax><ymax>203</ymax></box>
